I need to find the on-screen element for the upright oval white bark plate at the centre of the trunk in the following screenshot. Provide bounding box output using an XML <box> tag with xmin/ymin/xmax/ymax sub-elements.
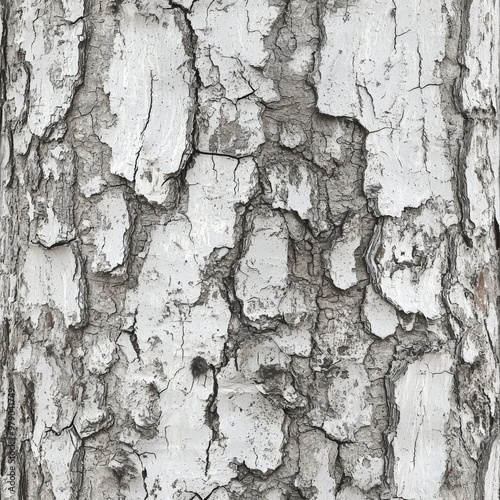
<box><xmin>235</xmin><ymin>209</ymin><xmax>288</xmax><ymax>323</ymax></box>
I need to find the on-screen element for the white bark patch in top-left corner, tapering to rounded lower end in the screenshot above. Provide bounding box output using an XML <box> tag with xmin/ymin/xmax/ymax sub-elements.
<box><xmin>16</xmin><ymin>0</ymin><xmax>84</xmax><ymax>136</ymax></box>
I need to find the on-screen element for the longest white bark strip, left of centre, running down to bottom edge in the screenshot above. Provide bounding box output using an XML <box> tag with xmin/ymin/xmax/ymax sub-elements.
<box><xmin>117</xmin><ymin>202</ymin><xmax>242</xmax><ymax>500</ymax></box>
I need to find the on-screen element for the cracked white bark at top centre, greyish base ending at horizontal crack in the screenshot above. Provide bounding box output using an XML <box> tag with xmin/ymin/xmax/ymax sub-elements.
<box><xmin>188</xmin><ymin>0</ymin><xmax>281</xmax><ymax>157</ymax></box>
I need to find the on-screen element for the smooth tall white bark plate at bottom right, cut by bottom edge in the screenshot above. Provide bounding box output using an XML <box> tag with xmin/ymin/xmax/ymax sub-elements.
<box><xmin>392</xmin><ymin>353</ymin><xmax>453</xmax><ymax>500</ymax></box>
